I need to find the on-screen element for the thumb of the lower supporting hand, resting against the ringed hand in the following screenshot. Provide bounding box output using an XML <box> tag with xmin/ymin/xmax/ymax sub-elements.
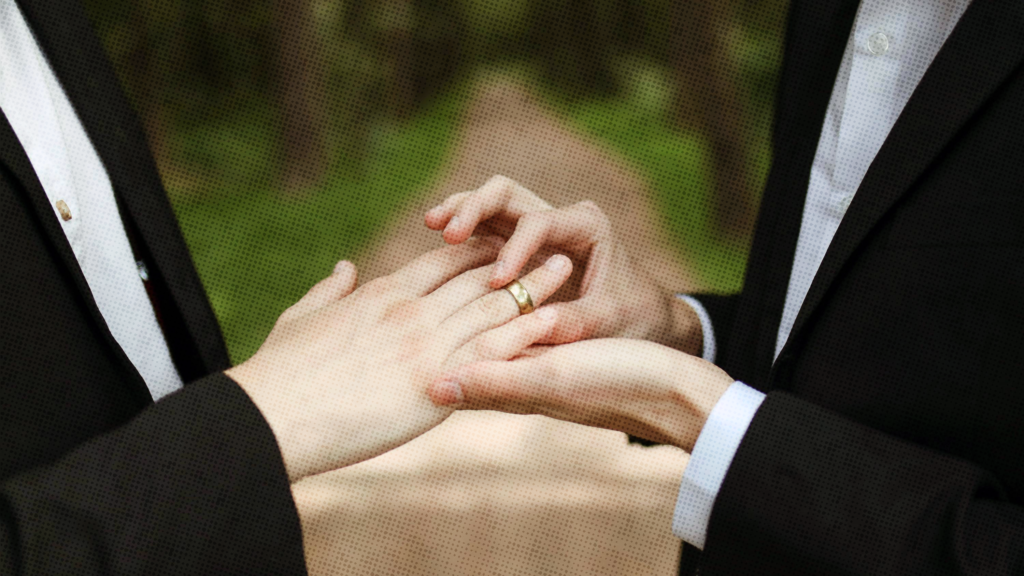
<box><xmin>427</xmin><ymin>357</ymin><xmax>545</xmax><ymax>414</ymax></box>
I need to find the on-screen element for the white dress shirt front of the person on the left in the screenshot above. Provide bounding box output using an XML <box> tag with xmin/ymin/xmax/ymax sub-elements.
<box><xmin>0</xmin><ymin>0</ymin><xmax>182</xmax><ymax>400</ymax></box>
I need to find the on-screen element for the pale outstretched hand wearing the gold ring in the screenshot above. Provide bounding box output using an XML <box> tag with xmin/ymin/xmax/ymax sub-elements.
<box><xmin>227</xmin><ymin>239</ymin><xmax>572</xmax><ymax>482</ymax></box>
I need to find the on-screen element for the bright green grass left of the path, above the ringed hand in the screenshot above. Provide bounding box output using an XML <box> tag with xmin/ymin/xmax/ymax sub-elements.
<box><xmin>170</xmin><ymin>87</ymin><xmax>465</xmax><ymax>362</ymax></box>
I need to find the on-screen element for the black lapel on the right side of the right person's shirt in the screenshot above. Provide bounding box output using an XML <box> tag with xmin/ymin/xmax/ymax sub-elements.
<box><xmin>780</xmin><ymin>0</ymin><xmax>1024</xmax><ymax>377</ymax></box>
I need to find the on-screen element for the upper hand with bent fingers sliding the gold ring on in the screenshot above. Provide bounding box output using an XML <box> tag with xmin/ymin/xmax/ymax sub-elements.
<box><xmin>425</xmin><ymin>176</ymin><xmax>702</xmax><ymax>354</ymax></box>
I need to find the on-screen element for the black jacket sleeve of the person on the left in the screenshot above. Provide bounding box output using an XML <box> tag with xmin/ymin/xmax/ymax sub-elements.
<box><xmin>0</xmin><ymin>373</ymin><xmax>305</xmax><ymax>576</ymax></box>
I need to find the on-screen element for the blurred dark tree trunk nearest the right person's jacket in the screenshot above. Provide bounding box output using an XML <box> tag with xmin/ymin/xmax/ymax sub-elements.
<box><xmin>672</xmin><ymin>0</ymin><xmax>757</xmax><ymax>240</ymax></box>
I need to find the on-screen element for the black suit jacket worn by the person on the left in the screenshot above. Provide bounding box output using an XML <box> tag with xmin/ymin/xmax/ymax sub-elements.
<box><xmin>0</xmin><ymin>0</ymin><xmax>305</xmax><ymax>575</ymax></box>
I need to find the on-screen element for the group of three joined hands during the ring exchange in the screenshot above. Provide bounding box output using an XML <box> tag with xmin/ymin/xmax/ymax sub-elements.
<box><xmin>227</xmin><ymin>177</ymin><xmax>732</xmax><ymax>481</ymax></box>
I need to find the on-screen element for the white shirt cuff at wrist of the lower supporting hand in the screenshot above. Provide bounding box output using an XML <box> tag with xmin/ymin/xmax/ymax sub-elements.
<box><xmin>672</xmin><ymin>381</ymin><xmax>765</xmax><ymax>550</ymax></box>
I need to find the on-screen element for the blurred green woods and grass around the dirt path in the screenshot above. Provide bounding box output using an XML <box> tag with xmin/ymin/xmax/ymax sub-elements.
<box><xmin>86</xmin><ymin>0</ymin><xmax>786</xmax><ymax>362</ymax></box>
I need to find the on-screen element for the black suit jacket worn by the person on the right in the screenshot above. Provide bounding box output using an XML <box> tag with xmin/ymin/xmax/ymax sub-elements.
<box><xmin>683</xmin><ymin>0</ymin><xmax>1024</xmax><ymax>576</ymax></box>
